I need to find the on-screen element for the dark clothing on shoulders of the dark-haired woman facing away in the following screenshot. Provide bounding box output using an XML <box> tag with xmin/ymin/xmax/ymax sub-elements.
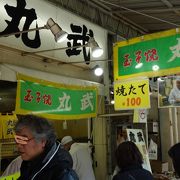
<box><xmin>113</xmin><ymin>165</ymin><xmax>153</xmax><ymax>180</ymax></box>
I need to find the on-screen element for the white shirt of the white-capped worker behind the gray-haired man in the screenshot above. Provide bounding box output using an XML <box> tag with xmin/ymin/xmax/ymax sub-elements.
<box><xmin>69</xmin><ymin>143</ymin><xmax>95</xmax><ymax>180</ymax></box>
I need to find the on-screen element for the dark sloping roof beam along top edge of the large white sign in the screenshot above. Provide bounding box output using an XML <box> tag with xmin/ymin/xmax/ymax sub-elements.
<box><xmin>46</xmin><ymin>0</ymin><xmax>148</xmax><ymax>38</ymax></box>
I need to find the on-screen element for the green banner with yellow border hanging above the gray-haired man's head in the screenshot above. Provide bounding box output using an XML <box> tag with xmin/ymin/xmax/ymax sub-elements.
<box><xmin>16</xmin><ymin>75</ymin><xmax>97</xmax><ymax>119</ymax></box>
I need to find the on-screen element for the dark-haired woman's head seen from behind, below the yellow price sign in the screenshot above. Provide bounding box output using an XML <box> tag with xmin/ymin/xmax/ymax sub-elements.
<box><xmin>115</xmin><ymin>141</ymin><xmax>143</xmax><ymax>169</ymax></box>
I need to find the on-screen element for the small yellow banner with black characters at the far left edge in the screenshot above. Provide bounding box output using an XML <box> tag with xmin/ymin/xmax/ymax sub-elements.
<box><xmin>0</xmin><ymin>114</ymin><xmax>17</xmax><ymax>139</ymax></box>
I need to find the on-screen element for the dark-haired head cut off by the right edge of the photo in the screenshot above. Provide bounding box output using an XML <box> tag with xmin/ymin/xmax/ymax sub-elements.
<box><xmin>168</xmin><ymin>143</ymin><xmax>180</xmax><ymax>176</ymax></box>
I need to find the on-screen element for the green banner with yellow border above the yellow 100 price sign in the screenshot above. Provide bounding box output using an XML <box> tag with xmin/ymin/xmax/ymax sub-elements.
<box><xmin>114</xmin><ymin>30</ymin><xmax>180</xmax><ymax>80</ymax></box>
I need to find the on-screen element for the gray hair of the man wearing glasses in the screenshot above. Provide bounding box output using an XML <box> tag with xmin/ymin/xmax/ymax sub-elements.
<box><xmin>14</xmin><ymin>115</ymin><xmax>56</xmax><ymax>146</ymax></box>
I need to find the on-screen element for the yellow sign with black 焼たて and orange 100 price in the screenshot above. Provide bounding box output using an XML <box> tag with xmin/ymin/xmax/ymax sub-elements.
<box><xmin>114</xmin><ymin>79</ymin><xmax>150</xmax><ymax>110</ymax></box>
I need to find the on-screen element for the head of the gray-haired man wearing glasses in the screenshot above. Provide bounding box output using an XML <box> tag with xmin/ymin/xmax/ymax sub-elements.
<box><xmin>14</xmin><ymin>115</ymin><xmax>56</xmax><ymax>160</ymax></box>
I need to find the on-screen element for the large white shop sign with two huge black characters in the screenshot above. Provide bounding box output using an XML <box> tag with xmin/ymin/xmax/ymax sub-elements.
<box><xmin>0</xmin><ymin>0</ymin><xmax>107</xmax><ymax>66</ymax></box>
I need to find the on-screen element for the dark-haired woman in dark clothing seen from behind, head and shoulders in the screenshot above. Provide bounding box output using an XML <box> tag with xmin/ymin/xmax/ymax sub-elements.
<box><xmin>113</xmin><ymin>141</ymin><xmax>153</xmax><ymax>180</ymax></box>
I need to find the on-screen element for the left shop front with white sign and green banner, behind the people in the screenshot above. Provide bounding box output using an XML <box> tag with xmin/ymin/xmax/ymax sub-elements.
<box><xmin>0</xmin><ymin>0</ymin><xmax>107</xmax><ymax>179</ymax></box>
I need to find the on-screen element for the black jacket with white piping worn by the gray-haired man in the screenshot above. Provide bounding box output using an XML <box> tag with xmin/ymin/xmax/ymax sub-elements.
<box><xmin>18</xmin><ymin>143</ymin><xmax>78</xmax><ymax>180</ymax></box>
